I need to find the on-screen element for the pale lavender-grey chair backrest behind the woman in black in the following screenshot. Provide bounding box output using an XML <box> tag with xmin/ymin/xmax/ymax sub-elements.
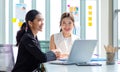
<box><xmin>0</xmin><ymin>44</ymin><xmax>14</xmax><ymax>72</ymax></box>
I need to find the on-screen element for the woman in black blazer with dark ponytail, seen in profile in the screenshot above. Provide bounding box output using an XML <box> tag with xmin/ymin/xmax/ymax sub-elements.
<box><xmin>12</xmin><ymin>10</ymin><xmax>58</xmax><ymax>72</ymax></box>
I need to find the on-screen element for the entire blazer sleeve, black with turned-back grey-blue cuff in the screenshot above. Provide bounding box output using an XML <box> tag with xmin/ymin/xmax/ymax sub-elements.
<box><xmin>23</xmin><ymin>37</ymin><xmax>56</xmax><ymax>63</ymax></box>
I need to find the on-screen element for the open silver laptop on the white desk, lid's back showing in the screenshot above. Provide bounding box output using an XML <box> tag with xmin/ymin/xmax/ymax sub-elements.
<box><xmin>50</xmin><ymin>40</ymin><xmax>100</xmax><ymax>65</ymax></box>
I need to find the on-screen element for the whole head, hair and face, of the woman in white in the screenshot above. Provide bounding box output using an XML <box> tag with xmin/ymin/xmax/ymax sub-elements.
<box><xmin>60</xmin><ymin>12</ymin><xmax>74</xmax><ymax>34</ymax></box>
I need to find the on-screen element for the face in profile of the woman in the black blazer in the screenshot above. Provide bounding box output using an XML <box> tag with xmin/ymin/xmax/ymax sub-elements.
<box><xmin>30</xmin><ymin>14</ymin><xmax>44</xmax><ymax>32</ymax></box>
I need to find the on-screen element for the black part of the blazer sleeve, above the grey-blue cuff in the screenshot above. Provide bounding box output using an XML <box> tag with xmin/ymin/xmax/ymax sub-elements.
<box><xmin>23</xmin><ymin>37</ymin><xmax>47</xmax><ymax>63</ymax></box>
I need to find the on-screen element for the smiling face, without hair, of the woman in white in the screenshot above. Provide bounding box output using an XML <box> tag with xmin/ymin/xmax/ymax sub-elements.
<box><xmin>61</xmin><ymin>17</ymin><xmax>74</xmax><ymax>33</ymax></box>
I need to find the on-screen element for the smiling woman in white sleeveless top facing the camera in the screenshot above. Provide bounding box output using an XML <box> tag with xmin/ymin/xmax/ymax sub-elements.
<box><xmin>50</xmin><ymin>12</ymin><xmax>79</xmax><ymax>58</ymax></box>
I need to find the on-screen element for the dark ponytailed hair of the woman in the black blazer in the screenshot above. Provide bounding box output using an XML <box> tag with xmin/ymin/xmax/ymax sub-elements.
<box><xmin>16</xmin><ymin>10</ymin><xmax>41</xmax><ymax>46</ymax></box>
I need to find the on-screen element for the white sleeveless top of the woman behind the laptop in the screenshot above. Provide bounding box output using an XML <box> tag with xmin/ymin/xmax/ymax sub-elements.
<box><xmin>54</xmin><ymin>32</ymin><xmax>79</xmax><ymax>54</ymax></box>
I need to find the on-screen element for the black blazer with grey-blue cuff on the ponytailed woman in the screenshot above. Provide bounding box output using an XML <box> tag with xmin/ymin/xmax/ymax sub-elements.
<box><xmin>12</xmin><ymin>30</ymin><xmax>56</xmax><ymax>72</ymax></box>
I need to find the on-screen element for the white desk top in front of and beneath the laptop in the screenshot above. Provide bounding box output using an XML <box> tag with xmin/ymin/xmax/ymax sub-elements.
<box><xmin>44</xmin><ymin>62</ymin><xmax>120</xmax><ymax>72</ymax></box>
